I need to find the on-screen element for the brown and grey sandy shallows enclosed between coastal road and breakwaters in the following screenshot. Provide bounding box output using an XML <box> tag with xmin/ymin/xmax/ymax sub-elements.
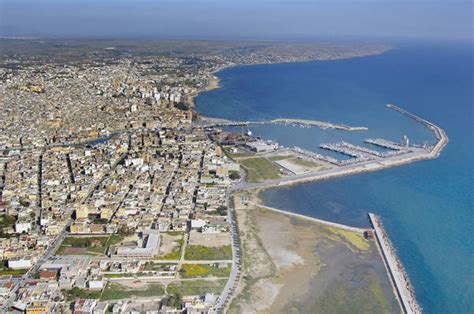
<box><xmin>229</xmin><ymin>194</ymin><xmax>400</xmax><ymax>313</ymax></box>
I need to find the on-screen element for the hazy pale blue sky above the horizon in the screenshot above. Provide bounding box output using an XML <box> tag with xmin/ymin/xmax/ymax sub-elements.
<box><xmin>0</xmin><ymin>0</ymin><xmax>474</xmax><ymax>40</ymax></box>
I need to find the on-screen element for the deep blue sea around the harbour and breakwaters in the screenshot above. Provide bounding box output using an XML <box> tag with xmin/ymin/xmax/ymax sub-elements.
<box><xmin>196</xmin><ymin>43</ymin><xmax>474</xmax><ymax>313</ymax></box>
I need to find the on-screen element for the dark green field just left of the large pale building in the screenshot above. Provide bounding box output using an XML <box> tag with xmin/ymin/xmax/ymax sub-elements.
<box><xmin>55</xmin><ymin>234</ymin><xmax>124</xmax><ymax>255</ymax></box>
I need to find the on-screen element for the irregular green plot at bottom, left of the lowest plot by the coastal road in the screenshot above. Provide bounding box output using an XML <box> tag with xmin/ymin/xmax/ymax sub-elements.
<box><xmin>100</xmin><ymin>282</ymin><xmax>165</xmax><ymax>301</ymax></box>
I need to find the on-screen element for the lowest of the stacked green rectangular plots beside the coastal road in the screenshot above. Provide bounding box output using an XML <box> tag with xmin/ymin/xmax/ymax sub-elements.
<box><xmin>167</xmin><ymin>279</ymin><xmax>227</xmax><ymax>295</ymax></box>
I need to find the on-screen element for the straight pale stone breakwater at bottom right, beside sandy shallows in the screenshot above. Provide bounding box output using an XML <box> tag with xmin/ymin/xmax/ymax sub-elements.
<box><xmin>368</xmin><ymin>213</ymin><xmax>421</xmax><ymax>314</ymax></box>
